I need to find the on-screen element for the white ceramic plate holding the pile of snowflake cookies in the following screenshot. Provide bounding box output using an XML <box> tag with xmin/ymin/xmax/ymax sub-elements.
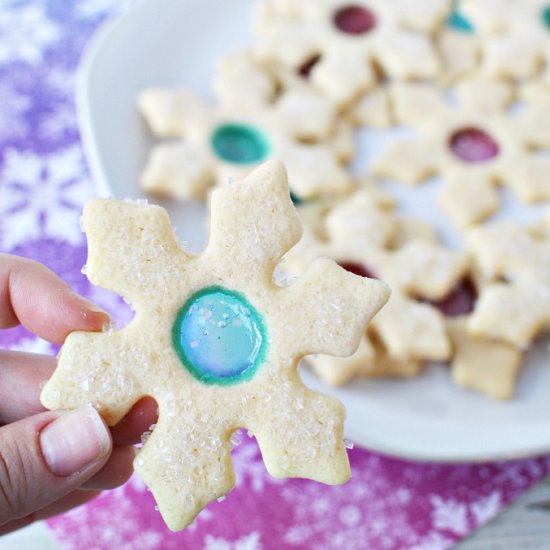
<box><xmin>78</xmin><ymin>0</ymin><xmax>550</xmax><ymax>461</ymax></box>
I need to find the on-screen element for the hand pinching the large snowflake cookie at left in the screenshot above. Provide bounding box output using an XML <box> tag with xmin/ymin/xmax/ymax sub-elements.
<box><xmin>0</xmin><ymin>254</ymin><xmax>156</xmax><ymax>535</ymax></box>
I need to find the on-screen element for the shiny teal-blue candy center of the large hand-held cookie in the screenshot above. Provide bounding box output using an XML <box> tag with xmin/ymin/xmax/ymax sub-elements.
<box><xmin>172</xmin><ymin>286</ymin><xmax>267</xmax><ymax>385</ymax></box>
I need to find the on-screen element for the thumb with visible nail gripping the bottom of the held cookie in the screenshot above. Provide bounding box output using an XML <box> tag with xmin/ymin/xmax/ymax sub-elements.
<box><xmin>0</xmin><ymin>406</ymin><xmax>112</xmax><ymax>525</ymax></box>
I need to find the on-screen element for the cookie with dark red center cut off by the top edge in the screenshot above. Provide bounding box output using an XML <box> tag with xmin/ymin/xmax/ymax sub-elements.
<box><xmin>256</xmin><ymin>0</ymin><xmax>449</xmax><ymax>103</ymax></box>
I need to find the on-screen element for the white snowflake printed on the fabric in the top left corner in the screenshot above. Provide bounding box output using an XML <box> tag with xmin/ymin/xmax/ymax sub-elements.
<box><xmin>0</xmin><ymin>2</ymin><xmax>61</xmax><ymax>66</ymax></box>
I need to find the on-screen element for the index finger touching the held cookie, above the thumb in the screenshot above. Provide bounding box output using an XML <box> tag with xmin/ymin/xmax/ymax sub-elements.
<box><xmin>0</xmin><ymin>254</ymin><xmax>110</xmax><ymax>344</ymax></box>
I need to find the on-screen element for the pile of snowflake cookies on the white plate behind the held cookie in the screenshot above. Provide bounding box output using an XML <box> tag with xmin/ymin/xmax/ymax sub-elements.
<box><xmin>137</xmin><ymin>0</ymin><xmax>550</xmax><ymax>406</ymax></box>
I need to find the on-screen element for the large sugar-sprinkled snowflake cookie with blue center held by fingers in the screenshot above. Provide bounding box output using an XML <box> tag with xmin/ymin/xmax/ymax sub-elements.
<box><xmin>42</xmin><ymin>161</ymin><xmax>389</xmax><ymax>530</ymax></box>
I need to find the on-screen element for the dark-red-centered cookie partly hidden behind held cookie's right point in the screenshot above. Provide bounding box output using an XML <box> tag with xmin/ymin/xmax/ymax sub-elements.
<box><xmin>283</xmin><ymin>188</ymin><xmax>468</xmax><ymax>385</ymax></box>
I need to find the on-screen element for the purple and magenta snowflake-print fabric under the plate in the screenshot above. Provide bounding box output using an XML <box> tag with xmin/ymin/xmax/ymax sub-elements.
<box><xmin>0</xmin><ymin>0</ymin><xmax>550</xmax><ymax>550</ymax></box>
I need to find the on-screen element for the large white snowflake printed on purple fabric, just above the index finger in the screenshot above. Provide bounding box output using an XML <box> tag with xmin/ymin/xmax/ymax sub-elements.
<box><xmin>0</xmin><ymin>145</ymin><xmax>91</xmax><ymax>250</ymax></box>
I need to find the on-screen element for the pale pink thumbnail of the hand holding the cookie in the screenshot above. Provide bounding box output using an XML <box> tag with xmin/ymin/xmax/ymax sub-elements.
<box><xmin>40</xmin><ymin>406</ymin><xmax>111</xmax><ymax>477</ymax></box>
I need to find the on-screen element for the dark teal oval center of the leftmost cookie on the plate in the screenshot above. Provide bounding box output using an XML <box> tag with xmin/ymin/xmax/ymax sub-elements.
<box><xmin>211</xmin><ymin>123</ymin><xmax>269</xmax><ymax>164</ymax></box>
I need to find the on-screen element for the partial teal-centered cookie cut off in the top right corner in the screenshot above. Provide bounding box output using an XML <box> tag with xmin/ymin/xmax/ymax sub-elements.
<box><xmin>462</xmin><ymin>0</ymin><xmax>550</xmax><ymax>79</ymax></box>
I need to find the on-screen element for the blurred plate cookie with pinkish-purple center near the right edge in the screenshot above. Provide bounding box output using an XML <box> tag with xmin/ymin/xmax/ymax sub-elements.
<box><xmin>372</xmin><ymin>79</ymin><xmax>550</xmax><ymax>227</ymax></box>
